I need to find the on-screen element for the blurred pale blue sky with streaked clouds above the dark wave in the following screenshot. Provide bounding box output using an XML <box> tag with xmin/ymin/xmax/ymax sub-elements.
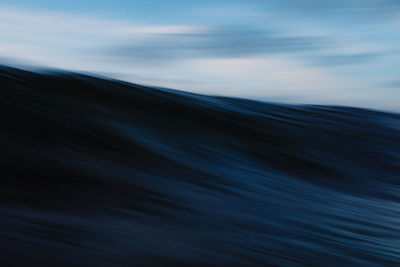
<box><xmin>0</xmin><ymin>0</ymin><xmax>400</xmax><ymax>111</ymax></box>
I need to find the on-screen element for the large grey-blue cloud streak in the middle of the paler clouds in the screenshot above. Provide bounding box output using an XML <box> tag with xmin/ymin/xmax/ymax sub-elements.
<box><xmin>109</xmin><ymin>26</ymin><xmax>326</xmax><ymax>63</ymax></box>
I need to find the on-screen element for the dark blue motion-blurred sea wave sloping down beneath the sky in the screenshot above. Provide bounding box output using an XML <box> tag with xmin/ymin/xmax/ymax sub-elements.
<box><xmin>0</xmin><ymin>66</ymin><xmax>400</xmax><ymax>266</ymax></box>
